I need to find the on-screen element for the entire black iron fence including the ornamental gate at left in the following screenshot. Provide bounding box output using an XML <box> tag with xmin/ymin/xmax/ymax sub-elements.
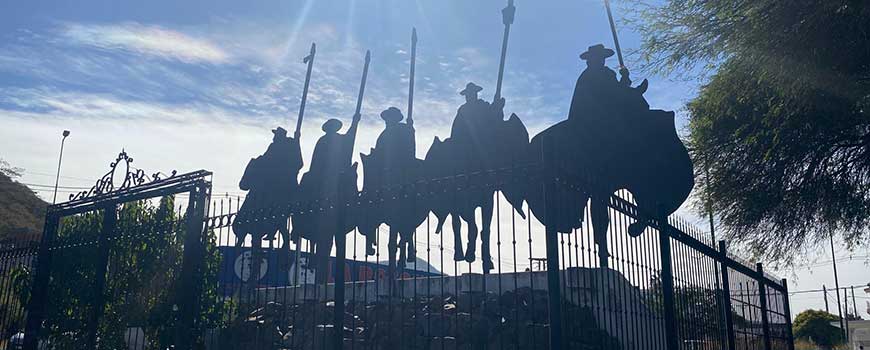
<box><xmin>0</xmin><ymin>165</ymin><xmax>793</xmax><ymax>350</ymax></box>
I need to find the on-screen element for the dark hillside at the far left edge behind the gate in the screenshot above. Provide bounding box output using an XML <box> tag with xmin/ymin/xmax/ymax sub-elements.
<box><xmin>0</xmin><ymin>172</ymin><xmax>48</xmax><ymax>242</ymax></box>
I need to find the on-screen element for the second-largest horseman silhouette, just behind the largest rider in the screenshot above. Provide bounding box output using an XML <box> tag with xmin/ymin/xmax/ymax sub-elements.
<box><xmin>424</xmin><ymin>83</ymin><xmax>529</xmax><ymax>271</ymax></box>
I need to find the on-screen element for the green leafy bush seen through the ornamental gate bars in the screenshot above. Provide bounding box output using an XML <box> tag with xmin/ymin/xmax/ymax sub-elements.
<box><xmin>31</xmin><ymin>197</ymin><xmax>223</xmax><ymax>349</ymax></box>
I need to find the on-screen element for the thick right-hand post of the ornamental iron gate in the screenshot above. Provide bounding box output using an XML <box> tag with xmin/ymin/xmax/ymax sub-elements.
<box><xmin>173</xmin><ymin>180</ymin><xmax>211</xmax><ymax>350</ymax></box>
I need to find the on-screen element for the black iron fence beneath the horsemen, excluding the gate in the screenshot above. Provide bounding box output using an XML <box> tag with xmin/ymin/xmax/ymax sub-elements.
<box><xmin>198</xmin><ymin>169</ymin><xmax>792</xmax><ymax>349</ymax></box>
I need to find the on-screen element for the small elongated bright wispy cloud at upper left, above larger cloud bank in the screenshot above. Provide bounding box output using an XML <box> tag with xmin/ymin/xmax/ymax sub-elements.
<box><xmin>63</xmin><ymin>22</ymin><xmax>231</xmax><ymax>63</ymax></box>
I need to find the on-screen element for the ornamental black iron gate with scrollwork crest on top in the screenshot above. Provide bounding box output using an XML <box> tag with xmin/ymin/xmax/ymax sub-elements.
<box><xmin>0</xmin><ymin>152</ymin><xmax>211</xmax><ymax>350</ymax></box>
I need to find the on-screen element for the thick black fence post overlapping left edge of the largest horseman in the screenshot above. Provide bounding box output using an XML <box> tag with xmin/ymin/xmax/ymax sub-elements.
<box><xmin>544</xmin><ymin>179</ymin><xmax>562</xmax><ymax>350</ymax></box>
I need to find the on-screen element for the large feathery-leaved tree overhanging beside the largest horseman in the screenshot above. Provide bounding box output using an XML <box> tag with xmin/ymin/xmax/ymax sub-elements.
<box><xmin>630</xmin><ymin>0</ymin><xmax>870</xmax><ymax>262</ymax></box>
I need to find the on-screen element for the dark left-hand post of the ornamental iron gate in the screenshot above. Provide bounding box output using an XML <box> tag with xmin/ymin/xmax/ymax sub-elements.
<box><xmin>24</xmin><ymin>213</ymin><xmax>60</xmax><ymax>350</ymax></box>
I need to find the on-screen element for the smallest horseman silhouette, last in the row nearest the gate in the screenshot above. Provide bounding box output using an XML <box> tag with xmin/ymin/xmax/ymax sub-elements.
<box><xmin>232</xmin><ymin>127</ymin><xmax>302</xmax><ymax>252</ymax></box>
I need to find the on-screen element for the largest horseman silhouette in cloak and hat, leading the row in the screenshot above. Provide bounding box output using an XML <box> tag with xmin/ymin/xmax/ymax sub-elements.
<box><xmin>526</xmin><ymin>44</ymin><xmax>694</xmax><ymax>266</ymax></box>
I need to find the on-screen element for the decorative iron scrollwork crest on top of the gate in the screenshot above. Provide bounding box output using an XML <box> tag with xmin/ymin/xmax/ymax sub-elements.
<box><xmin>69</xmin><ymin>150</ymin><xmax>177</xmax><ymax>201</ymax></box>
